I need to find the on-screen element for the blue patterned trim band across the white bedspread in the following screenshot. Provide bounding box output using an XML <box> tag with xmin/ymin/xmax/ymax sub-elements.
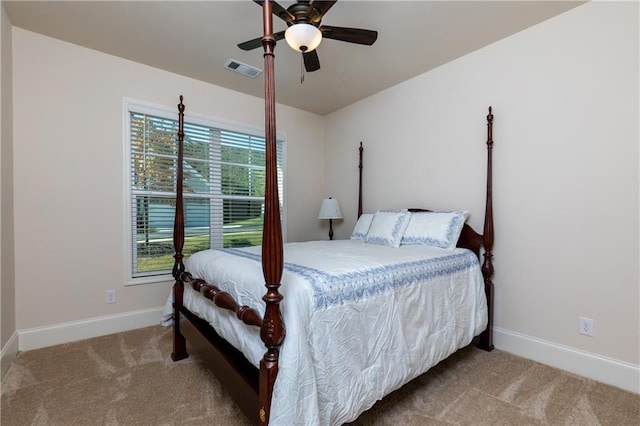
<box><xmin>218</xmin><ymin>249</ymin><xmax>479</xmax><ymax>309</ymax></box>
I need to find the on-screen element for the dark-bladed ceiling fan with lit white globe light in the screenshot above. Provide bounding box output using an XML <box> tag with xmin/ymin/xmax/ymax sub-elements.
<box><xmin>238</xmin><ymin>0</ymin><xmax>378</xmax><ymax>72</ymax></box>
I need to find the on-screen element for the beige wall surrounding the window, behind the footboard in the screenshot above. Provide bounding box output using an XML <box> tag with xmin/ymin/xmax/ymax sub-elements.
<box><xmin>13</xmin><ymin>28</ymin><xmax>324</xmax><ymax>332</ymax></box>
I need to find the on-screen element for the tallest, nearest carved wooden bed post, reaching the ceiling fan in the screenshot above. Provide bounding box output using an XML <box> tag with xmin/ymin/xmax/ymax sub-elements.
<box><xmin>258</xmin><ymin>0</ymin><xmax>285</xmax><ymax>424</ymax></box>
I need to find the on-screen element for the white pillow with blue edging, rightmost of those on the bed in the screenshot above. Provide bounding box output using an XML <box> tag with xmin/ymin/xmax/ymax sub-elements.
<box><xmin>402</xmin><ymin>211</ymin><xmax>469</xmax><ymax>249</ymax></box>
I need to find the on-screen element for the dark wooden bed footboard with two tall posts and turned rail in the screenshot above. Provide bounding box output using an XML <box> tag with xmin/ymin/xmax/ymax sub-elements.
<box><xmin>171</xmin><ymin>1</ymin><xmax>285</xmax><ymax>424</ymax></box>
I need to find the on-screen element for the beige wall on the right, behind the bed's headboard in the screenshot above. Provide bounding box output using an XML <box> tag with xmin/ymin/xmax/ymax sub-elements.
<box><xmin>326</xmin><ymin>2</ymin><xmax>640</xmax><ymax>370</ymax></box>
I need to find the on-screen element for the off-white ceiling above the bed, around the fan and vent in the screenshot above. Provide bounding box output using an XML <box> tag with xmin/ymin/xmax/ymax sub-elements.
<box><xmin>2</xmin><ymin>0</ymin><xmax>581</xmax><ymax>115</ymax></box>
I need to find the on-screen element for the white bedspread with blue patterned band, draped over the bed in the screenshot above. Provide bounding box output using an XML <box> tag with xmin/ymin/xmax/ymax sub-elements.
<box><xmin>178</xmin><ymin>240</ymin><xmax>487</xmax><ymax>426</ymax></box>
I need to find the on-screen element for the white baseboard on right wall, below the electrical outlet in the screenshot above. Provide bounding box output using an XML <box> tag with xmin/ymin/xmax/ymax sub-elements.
<box><xmin>493</xmin><ymin>327</ymin><xmax>640</xmax><ymax>394</ymax></box>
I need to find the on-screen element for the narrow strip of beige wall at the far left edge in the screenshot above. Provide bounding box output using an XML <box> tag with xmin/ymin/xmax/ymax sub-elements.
<box><xmin>0</xmin><ymin>2</ymin><xmax>17</xmax><ymax>377</ymax></box>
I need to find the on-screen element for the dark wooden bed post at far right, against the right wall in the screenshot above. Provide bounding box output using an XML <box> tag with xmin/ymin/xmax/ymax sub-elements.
<box><xmin>478</xmin><ymin>107</ymin><xmax>494</xmax><ymax>351</ymax></box>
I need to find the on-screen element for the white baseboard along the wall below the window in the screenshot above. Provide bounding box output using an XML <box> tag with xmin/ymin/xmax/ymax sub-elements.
<box><xmin>18</xmin><ymin>306</ymin><xmax>164</xmax><ymax>351</ymax></box>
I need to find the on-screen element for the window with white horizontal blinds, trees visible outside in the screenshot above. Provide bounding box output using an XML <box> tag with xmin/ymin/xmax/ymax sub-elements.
<box><xmin>126</xmin><ymin>102</ymin><xmax>284</xmax><ymax>284</ymax></box>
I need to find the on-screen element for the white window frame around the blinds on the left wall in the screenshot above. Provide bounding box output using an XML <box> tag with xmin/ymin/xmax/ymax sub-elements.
<box><xmin>123</xmin><ymin>97</ymin><xmax>287</xmax><ymax>286</ymax></box>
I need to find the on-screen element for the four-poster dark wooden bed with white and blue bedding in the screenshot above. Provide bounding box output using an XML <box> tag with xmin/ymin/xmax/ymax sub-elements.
<box><xmin>171</xmin><ymin>1</ymin><xmax>493</xmax><ymax>424</ymax></box>
